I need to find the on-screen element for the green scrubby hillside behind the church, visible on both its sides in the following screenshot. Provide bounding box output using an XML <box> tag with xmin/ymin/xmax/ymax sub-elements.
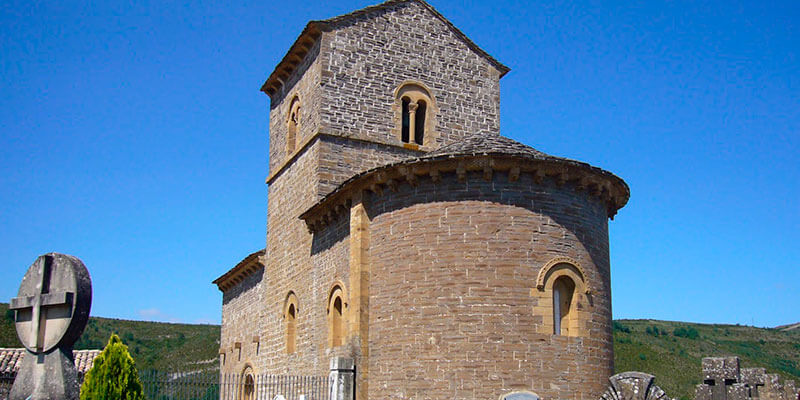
<box><xmin>0</xmin><ymin>303</ymin><xmax>800</xmax><ymax>399</ymax></box>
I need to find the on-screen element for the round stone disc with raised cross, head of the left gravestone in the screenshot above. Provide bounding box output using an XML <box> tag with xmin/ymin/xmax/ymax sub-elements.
<box><xmin>8</xmin><ymin>253</ymin><xmax>92</xmax><ymax>354</ymax></box>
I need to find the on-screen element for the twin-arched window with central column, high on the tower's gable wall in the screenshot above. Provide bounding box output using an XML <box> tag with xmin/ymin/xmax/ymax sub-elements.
<box><xmin>394</xmin><ymin>82</ymin><xmax>435</xmax><ymax>146</ymax></box>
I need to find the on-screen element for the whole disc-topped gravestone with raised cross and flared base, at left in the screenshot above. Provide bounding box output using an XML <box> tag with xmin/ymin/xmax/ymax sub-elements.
<box><xmin>9</xmin><ymin>253</ymin><xmax>92</xmax><ymax>400</ymax></box>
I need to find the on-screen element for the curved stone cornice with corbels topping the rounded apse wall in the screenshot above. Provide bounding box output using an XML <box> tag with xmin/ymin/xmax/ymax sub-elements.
<box><xmin>300</xmin><ymin>154</ymin><xmax>630</xmax><ymax>232</ymax></box>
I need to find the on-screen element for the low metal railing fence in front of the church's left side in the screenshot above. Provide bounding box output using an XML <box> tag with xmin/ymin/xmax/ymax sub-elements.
<box><xmin>139</xmin><ymin>371</ymin><xmax>330</xmax><ymax>400</ymax></box>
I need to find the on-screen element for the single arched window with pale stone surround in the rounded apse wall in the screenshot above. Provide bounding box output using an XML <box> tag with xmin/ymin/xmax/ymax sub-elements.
<box><xmin>531</xmin><ymin>257</ymin><xmax>592</xmax><ymax>336</ymax></box>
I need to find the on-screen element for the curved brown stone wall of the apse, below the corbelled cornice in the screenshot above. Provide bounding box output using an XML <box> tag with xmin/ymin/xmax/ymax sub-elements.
<box><xmin>364</xmin><ymin>173</ymin><xmax>613</xmax><ymax>400</ymax></box>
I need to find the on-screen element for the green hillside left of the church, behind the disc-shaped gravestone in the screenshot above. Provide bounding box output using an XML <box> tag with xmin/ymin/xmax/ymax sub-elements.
<box><xmin>0</xmin><ymin>303</ymin><xmax>219</xmax><ymax>371</ymax></box>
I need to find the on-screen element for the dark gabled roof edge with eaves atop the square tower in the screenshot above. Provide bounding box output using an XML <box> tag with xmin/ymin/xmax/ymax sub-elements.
<box><xmin>261</xmin><ymin>0</ymin><xmax>511</xmax><ymax>96</ymax></box>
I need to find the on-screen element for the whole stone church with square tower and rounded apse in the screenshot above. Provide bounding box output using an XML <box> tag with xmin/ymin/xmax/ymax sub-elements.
<box><xmin>214</xmin><ymin>0</ymin><xmax>629</xmax><ymax>400</ymax></box>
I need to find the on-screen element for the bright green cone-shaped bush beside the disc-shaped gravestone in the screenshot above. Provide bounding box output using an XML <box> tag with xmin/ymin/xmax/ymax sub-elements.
<box><xmin>81</xmin><ymin>334</ymin><xmax>144</xmax><ymax>400</ymax></box>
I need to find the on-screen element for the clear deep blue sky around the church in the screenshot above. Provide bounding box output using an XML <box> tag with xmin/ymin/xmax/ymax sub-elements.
<box><xmin>0</xmin><ymin>0</ymin><xmax>800</xmax><ymax>326</ymax></box>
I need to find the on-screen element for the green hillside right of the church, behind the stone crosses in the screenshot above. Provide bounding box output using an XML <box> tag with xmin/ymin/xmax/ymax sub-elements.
<box><xmin>614</xmin><ymin>320</ymin><xmax>800</xmax><ymax>399</ymax></box>
